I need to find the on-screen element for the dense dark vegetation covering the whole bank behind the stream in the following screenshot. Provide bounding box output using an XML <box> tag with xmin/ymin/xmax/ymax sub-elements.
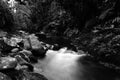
<box><xmin>0</xmin><ymin>0</ymin><xmax>120</xmax><ymax>79</ymax></box>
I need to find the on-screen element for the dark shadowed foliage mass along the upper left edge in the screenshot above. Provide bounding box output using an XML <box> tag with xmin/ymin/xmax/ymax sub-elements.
<box><xmin>0</xmin><ymin>0</ymin><xmax>14</xmax><ymax>31</ymax></box>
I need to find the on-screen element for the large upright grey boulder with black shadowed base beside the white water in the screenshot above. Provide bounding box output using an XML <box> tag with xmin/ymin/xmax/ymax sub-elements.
<box><xmin>24</xmin><ymin>34</ymin><xmax>46</xmax><ymax>57</ymax></box>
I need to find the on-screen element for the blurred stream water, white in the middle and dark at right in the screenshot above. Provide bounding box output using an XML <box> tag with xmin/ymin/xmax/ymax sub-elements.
<box><xmin>35</xmin><ymin>49</ymin><xmax>120</xmax><ymax>80</ymax></box>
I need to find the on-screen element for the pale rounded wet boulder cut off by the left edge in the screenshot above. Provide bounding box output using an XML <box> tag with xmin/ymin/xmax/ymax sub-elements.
<box><xmin>0</xmin><ymin>57</ymin><xmax>17</xmax><ymax>70</ymax></box>
